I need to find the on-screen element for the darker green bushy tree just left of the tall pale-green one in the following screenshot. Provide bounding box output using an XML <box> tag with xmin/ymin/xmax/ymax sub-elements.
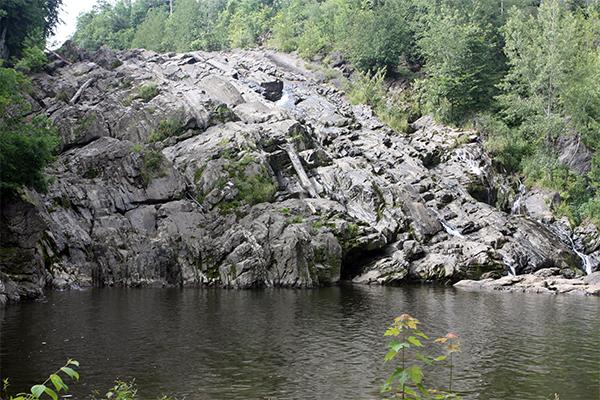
<box><xmin>418</xmin><ymin>2</ymin><xmax>501</xmax><ymax>123</ymax></box>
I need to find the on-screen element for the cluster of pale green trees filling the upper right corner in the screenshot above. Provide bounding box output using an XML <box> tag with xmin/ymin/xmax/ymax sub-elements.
<box><xmin>494</xmin><ymin>0</ymin><xmax>600</xmax><ymax>224</ymax></box>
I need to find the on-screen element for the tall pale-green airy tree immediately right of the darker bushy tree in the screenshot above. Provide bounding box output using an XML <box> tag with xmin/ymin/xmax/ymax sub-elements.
<box><xmin>499</xmin><ymin>0</ymin><xmax>577</xmax><ymax>140</ymax></box>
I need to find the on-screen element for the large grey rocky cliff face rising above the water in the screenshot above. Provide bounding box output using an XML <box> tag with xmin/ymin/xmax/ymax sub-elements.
<box><xmin>0</xmin><ymin>43</ymin><xmax>600</xmax><ymax>301</ymax></box>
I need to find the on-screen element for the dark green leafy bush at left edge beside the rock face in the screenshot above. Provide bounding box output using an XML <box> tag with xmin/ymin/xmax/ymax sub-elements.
<box><xmin>0</xmin><ymin>67</ymin><xmax>59</xmax><ymax>193</ymax></box>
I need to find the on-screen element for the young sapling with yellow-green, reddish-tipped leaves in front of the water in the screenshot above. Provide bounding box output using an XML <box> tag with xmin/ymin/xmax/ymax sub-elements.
<box><xmin>381</xmin><ymin>314</ymin><xmax>460</xmax><ymax>399</ymax></box>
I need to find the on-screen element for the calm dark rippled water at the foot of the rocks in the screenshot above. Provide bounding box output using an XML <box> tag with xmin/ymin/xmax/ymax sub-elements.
<box><xmin>0</xmin><ymin>286</ymin><xmax>600</xmax><ymax>400</ymax></box>
